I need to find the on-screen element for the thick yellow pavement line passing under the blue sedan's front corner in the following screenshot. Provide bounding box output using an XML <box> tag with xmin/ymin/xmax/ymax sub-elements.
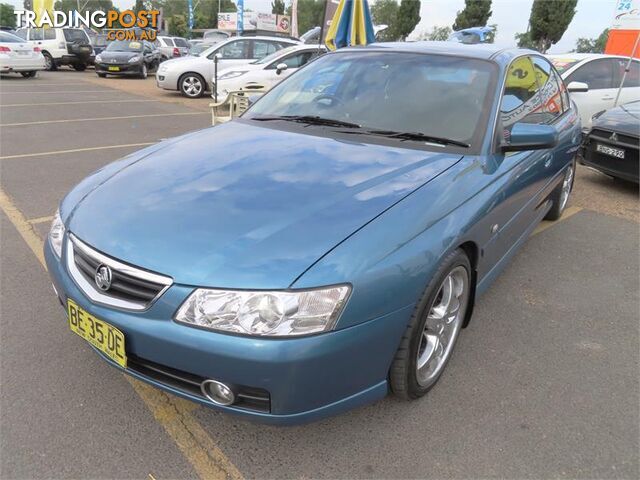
<box><xmin>0</xmin><ymin>188</ymin><xmax>243</xmax><ymax>480</ymax></box>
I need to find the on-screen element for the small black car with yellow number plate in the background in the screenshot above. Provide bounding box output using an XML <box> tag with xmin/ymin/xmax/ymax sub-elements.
<box><xmin>95</xmin><ymin>40</ymin><xmax>160</xmax><ymax>78</ymax></box>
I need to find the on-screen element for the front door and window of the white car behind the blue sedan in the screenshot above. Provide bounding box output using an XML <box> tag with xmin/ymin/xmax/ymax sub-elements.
<box><xmin>565</xmin><ymin>58</ymin><xmax>620</xmax><ymax>129</ymax></box>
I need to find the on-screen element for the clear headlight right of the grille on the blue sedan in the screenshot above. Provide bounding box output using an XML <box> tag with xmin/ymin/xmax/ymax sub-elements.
<box><xmin>175</xmin><ymin>285</ymin><xmax>350</xmax><ymax>336</ymax></box>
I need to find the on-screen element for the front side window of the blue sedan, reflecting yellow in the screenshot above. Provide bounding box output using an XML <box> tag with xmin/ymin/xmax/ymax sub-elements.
<box><xmin>500</xmin><ymin>57</ymin><xmax>544</xmax><ymax>130</ymax></box>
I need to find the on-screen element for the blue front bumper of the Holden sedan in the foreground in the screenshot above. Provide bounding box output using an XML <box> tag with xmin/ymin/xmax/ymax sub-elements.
<box><xmin>45</xmin><ymin>237</ymin><xmax>413</xmax><ymax>424</ymax></box>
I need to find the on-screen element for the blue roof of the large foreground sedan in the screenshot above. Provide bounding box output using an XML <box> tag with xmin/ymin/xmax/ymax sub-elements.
<box><xmin>345</xmin><ymin>41</ymin><xmax>538</xmax><ymax>60</ymax></box>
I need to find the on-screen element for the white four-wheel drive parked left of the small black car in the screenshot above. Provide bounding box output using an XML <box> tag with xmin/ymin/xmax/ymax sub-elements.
<box><xmin>16</xmin><ymin>28</ymin><xmax>94</xmax><ymax>71</ymax></box>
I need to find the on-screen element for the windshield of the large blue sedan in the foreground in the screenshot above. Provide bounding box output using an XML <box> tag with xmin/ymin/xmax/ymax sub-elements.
<box><xmin>248</xmin><ymin>51</ymin><xmax>497</xmax><ymax>147</ymax></box>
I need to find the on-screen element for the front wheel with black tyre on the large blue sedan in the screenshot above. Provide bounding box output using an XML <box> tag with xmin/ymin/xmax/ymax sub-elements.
<box><xmin>389</xmin><ymin>249</ymin><xmax>471</xmax><ymax>400</ymax></box>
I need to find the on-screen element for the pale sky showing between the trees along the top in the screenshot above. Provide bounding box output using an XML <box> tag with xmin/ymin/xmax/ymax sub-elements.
<box><xmin>5</xmin><ymin>0</ymin><xmax>616</xmax><ymax>53</ymax></box>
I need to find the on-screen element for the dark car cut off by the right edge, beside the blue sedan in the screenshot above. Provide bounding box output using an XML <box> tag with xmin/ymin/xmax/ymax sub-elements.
<box><xmin>582</xmin><ymin>102</ymin><xmax>640</xmax><ymax>183</ymax></box>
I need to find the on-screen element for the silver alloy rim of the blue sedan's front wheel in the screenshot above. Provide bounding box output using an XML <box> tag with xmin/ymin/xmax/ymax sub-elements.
<box><xmin>416</xmin><ymin>266</ymin><xmax>469</xmax><ymax>387</ymax></box>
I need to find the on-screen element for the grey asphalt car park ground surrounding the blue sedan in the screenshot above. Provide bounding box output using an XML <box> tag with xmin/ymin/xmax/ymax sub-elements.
<box><xmin>0</xmin><ymin>71</ymin><xmax>640</xmax><ymax>479</ymax></box>
